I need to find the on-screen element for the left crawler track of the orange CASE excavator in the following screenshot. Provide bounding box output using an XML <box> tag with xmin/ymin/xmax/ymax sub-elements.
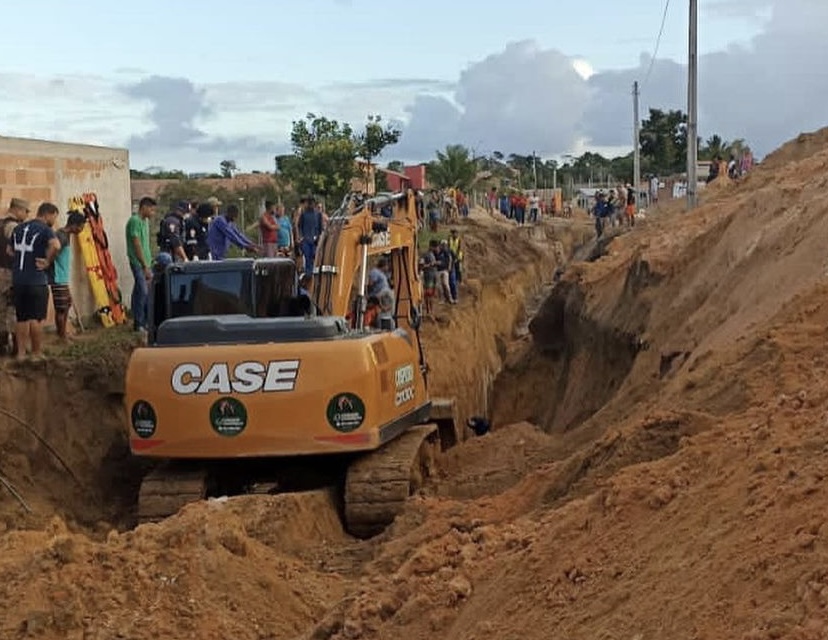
<box><xmin>138</xmin><ymin>467</ymin><xmax>207</xmax><ymax>524</ymax></box>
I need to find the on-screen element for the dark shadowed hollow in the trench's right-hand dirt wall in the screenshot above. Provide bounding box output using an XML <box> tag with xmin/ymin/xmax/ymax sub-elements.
<box><xmin>488</xmin><ymin>232</ymin><xmax>658</xmax><ymax>433</ymax></box>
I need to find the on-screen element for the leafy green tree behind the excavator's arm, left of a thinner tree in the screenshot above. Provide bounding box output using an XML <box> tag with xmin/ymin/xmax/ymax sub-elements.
<box><xmin>279</xmin><ymin>113</ymin><xmax>358</xmax><ymax>205</ymax></box>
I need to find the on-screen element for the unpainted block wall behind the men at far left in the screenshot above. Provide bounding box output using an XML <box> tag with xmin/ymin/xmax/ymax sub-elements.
<box><xmin>0</xmin><ymin>136</ymin><xmax>132</xmax><ymax>316</ymax></box>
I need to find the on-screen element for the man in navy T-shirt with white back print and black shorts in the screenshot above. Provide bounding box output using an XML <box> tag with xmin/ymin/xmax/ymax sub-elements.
<box><xmin>6</xmin><ymin>202</ymin><xmax>60</xmax><ymax>359</ymax></box>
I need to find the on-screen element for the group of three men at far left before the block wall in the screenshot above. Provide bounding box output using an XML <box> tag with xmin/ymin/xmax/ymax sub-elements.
<box><xmin>0</xmin><ymin>198</ymin><xmax>86</xmax><ymax>359</ymax></box>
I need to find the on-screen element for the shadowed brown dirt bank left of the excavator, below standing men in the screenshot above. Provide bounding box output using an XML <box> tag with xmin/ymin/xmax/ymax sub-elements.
<box><xmin>0</xmin><ymin>340</ymin><xmax>137</xmax><ymax>533</ymax></box>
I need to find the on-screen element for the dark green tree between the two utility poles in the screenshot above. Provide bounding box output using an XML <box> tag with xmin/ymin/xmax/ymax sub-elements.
<box><xmin>639</xmin><ymin>109</ymin><xmax>687</xmax><ymax>174</ymax></box>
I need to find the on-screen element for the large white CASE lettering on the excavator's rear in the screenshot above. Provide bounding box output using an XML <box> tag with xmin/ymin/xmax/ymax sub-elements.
<box><xmin>170</xmin><ymin>360</ymin><xmax>299</xmax><ymax>396</ymax></box>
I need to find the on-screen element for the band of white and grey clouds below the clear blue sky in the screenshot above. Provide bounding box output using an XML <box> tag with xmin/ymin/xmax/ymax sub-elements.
<box><xmin>0</xmin><ymin>0</ymin><xmax>828</xmax><ymax>170</ymax></box>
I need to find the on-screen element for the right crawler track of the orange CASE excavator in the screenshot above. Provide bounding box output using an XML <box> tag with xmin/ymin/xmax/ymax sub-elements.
<box><xmin>345</xmin><ymin>424</ymin><xmax>439</xmax><ymax>538</ymax></box>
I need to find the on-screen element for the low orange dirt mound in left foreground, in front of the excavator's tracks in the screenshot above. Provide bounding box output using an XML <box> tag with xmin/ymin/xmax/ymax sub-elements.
<box><xmin>0</xmin><ymin>494</ymin><xmax>345</xmax><ymax>640</ymax></box>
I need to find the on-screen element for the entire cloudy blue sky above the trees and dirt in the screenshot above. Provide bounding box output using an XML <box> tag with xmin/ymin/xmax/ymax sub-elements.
<box><xmin>0</xmin><ymin>0</ymin><xmax>828</xmax><ymax>171</ymax></box>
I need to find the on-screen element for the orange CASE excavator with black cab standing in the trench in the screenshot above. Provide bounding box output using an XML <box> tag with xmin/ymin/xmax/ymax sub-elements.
<box><xmin>125</xmin><ymin>190</ymin><xmax>464</xmax><ymax>537</ymax></box>
